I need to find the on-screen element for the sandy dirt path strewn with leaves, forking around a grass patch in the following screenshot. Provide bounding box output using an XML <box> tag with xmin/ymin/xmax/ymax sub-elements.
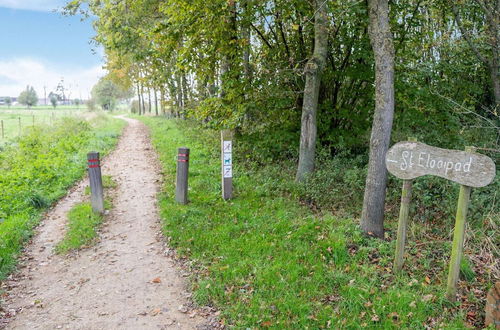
<box><xmin>0</xmin><ymin>118</ymin><xmax>213</xmax><ymax>329</ymax></box>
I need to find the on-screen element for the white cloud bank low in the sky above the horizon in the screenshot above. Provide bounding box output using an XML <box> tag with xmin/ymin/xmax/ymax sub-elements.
<box><xmin>0</xmin><ymin>58</ymin><xmax>106</xmax><ymax>99</ymax></box>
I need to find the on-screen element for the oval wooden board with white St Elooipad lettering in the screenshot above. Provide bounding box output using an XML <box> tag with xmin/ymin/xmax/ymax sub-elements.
<box><xmin>385</xmin><ymin>142</ymin><xmax>496</xmax><ymax>187</ymax></box>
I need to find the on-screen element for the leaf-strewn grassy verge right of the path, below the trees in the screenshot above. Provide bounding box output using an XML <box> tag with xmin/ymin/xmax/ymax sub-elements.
<box><xmin>142</xmin><ymin>118</ymin><xmax>490</xmax><ymax>329</ymax></box>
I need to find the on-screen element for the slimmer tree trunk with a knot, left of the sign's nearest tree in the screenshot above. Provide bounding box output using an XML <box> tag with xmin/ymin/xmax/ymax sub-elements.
<box><xmin>296</xmin><ymin>0</ymin><xmax>328</xmax><ymax>182</ymax></box>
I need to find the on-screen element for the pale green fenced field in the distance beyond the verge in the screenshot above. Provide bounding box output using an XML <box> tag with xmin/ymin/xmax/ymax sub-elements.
<box><xmin>0</xmin><ymin>105</ymin><xmax>86</xmax><ymax>145</ymax></box>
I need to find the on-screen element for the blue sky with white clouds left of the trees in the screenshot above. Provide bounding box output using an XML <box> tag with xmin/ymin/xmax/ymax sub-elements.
<box><xmin>0</xmin><ymin>0</ymin><xmax>105</xmax><ymax>99</ymax></box>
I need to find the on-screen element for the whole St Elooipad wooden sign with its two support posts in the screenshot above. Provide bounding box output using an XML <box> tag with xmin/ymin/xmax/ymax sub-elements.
<box><xmin>385</xmin><ymin>139</ymin><xmax>496</xmax><ymax>301</ymax></box>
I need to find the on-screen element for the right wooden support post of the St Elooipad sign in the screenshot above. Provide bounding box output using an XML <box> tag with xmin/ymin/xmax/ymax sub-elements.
<box><xmin>446</xmin><ymin>147</ymin><xmax>474</xmax><ymax>301</ymax></box>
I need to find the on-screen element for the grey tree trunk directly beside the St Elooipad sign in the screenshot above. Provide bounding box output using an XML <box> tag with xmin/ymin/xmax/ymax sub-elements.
<box><xmin>361</xmin><ymin>0</ymin><xmax>394</xmax><ymax>238</ymax></box>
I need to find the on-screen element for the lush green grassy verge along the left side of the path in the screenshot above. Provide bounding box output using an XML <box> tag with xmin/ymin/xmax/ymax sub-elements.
<box><xmin>0</xmin><ymin>115</ymin><xmax>125</xmax><ymax>278</ymax></box>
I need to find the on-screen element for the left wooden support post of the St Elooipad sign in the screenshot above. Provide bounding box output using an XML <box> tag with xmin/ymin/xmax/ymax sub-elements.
<box><xmin>394</xmin><ymin>138</ymin><xmax>417</xmax><ymax>273</ymax></box>
